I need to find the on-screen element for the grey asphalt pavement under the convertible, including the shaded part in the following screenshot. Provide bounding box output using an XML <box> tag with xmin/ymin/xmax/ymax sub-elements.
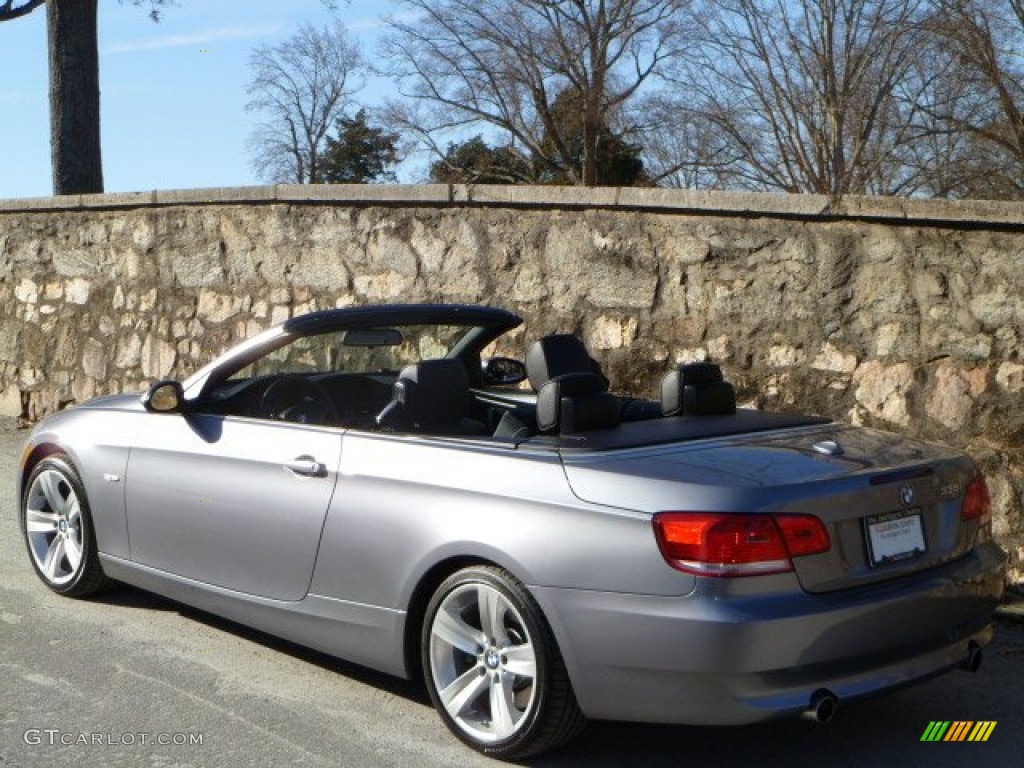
<box><xmin>0</xmin><ymin>420</ymin><xmax>1024</xmax><ymax>768</ymax></box>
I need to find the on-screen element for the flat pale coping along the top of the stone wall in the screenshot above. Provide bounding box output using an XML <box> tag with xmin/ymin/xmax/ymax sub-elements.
<box><xmin>0</xmin><ymin>184</ymin><xmax>1024</xmax><ymax>229</ymax></box>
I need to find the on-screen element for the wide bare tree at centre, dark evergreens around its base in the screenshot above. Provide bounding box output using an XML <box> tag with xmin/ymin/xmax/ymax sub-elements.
<box><xmin>386</xmin><ymin>0</ymin><xmax>688</xmax><ymax>185</ymax></box>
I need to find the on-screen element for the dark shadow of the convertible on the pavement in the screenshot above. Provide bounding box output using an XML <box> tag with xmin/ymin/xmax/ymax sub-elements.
<box><xmin>93</xmin><ymin>585</ymin><xmax>1024</xmax><ymax>768</ymax></box>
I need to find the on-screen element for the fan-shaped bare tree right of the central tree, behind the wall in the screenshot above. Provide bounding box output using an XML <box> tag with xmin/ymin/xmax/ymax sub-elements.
<box><xmin>679</xmin><ymin>0</ymin><xmax>924</xmax><ymax>198</ymax></box>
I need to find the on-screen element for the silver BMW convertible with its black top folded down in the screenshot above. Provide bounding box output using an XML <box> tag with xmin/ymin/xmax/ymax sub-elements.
<box><xmin>17</xmin><ymin>305</ymin><xmax>1005</xmax><ymax>759</ymax></box>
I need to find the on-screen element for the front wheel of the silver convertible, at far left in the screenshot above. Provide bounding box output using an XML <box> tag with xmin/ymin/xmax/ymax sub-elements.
<box><xmin>18</xmin><ymin>454</ymin><xmax>114</xmax><ymax>597</ymax></box>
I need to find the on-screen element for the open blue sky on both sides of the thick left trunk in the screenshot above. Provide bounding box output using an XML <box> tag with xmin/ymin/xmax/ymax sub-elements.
<box><xmin>0</xmin><ymin>0</ymin><xmax>401</xmax><ymax>199</ymax></box>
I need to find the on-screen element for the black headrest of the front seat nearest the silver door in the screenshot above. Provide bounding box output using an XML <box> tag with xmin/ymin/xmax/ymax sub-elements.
<box><xmin>392</xmin><ymin>359</ymin><xmax>470</xmax><ymax>427</ymax></box>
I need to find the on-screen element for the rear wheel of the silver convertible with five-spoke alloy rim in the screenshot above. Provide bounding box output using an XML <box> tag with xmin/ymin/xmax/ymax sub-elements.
<box><xmin>422</xmin><ymin>566</ymin><xmax>585</xmax><ymax>759</ymax></box>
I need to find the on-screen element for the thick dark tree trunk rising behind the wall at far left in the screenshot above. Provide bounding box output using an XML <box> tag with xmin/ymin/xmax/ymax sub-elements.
<box><xmin>46</xmin><ymin>0</ymin><xmax>103</xmax><ymax>195</ymax></box>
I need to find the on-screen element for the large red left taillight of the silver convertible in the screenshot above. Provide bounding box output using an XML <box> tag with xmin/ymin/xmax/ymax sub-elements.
<box><xmin>654</xmin><ymin>512</ymin><xmax>831</xmax><ymax>577</ymax></box>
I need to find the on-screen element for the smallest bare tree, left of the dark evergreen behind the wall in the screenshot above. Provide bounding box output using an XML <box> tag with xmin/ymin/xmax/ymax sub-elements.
<box><xmin>246</xmin><ymin>23</ymin><xmax>364</xmax><ymax>184</ymax></box>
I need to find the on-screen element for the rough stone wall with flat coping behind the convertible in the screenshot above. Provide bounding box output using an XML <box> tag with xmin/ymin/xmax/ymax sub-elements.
<box><xmin>0</xmin><ymin>185</ymin><xmax>1024</xmax><ymax>578</ymax></box>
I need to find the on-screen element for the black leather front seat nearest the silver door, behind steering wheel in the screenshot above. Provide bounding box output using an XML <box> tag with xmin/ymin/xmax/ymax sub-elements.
<box><xmin>377</xmin><ymin>359</ymin><xmax>487</xmax><ymax>435</ymax></box>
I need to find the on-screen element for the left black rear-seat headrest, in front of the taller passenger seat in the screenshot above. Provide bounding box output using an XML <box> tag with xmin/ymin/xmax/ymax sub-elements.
<box><xmin>537</xmin><ymin>374</ymin><xmax>621</xmax><ymax>434</ymax></box>
